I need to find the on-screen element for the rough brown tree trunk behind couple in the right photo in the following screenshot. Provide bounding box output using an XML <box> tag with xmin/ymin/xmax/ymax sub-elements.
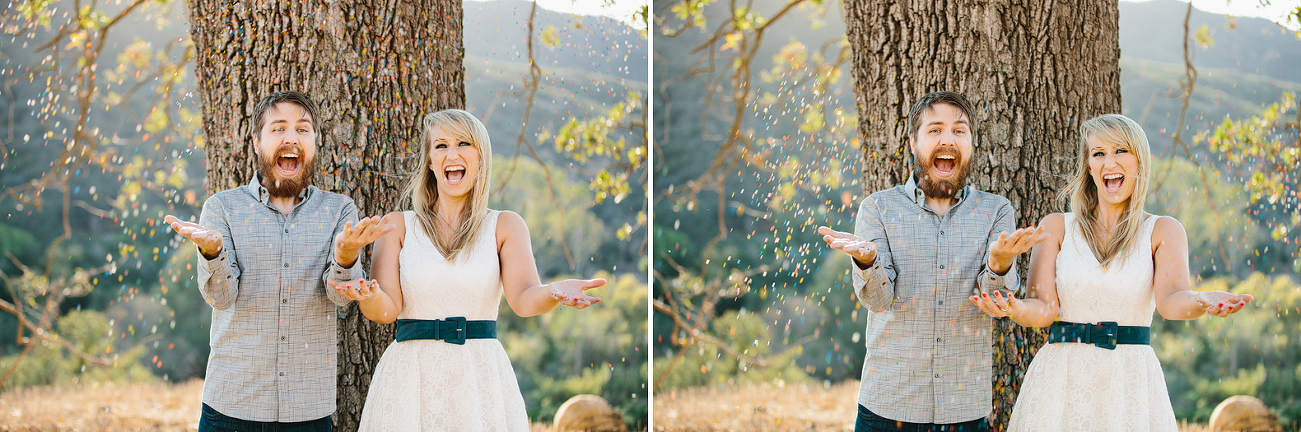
<box><xmin>844</xmin><ymin>0</ymin><xmax>1120</xmax><ymax>431</ymax></box>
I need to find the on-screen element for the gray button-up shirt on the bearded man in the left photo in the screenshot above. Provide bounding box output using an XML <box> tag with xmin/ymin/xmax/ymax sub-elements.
<box><xmin>198</xmin><ymin>176</ymin><xmax>366</xmax><ymax>422</ymax></box>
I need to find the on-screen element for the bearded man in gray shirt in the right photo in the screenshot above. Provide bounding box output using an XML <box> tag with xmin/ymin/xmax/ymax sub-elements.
<box><xmin>818</xmin><ymin>91</ymin><xmax>1045</xmax><ymax>431</ymax></box>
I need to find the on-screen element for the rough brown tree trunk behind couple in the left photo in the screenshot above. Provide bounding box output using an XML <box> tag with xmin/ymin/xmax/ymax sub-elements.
<box><xmin>190</xmin><ymin>0</ymin><xmax>466</xmax><ymax>431</ymax></box>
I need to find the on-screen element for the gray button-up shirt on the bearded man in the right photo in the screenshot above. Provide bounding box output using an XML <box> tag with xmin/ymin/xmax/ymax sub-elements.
<box><xmin>853</xmin><ymin>174</ymin><xmax>1019</xmax><ymax>424</ymax></box>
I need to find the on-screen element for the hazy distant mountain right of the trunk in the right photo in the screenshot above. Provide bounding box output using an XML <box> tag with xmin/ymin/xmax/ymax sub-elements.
<box><xmin>1120</xmin><ymin>0</ymin><xmax>1301</xmax><ymax>156</ymax></box>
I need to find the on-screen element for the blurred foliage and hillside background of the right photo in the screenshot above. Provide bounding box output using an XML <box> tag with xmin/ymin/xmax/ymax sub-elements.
<box><xmin>651</xmin><ymin>0</ymin><xmax>1301</xmax><ymax>431</ymax></box>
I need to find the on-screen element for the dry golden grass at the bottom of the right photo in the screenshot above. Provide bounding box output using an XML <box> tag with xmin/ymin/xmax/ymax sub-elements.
<box><xmin>652</xmin><ymin>380</ymin><xmax>1207</xmax><ymax>432</ymax></box>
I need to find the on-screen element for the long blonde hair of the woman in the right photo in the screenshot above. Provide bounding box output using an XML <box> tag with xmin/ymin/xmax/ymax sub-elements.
<box><xmin>1062</xmin><ymin>115</ymin><xmax>1151</xmax><ymax>268</ymax></box>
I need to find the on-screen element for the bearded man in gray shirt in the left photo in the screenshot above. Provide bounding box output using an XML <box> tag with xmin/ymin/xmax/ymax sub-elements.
<box><xmin>164</xmin><ymin>91</ymin><xmax>393</xmax><ymax>432</ymax></box>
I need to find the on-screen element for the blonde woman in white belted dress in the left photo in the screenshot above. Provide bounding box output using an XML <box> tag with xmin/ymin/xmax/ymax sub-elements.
<box><xmin>337</xmin><ymin>109</ymin><xmax>605</xmax><ymax>431</ymax></box>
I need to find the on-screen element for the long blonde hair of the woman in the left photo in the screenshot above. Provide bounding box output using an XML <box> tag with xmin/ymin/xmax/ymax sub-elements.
<box><xmin>403</xmin><ymin>109</ymin><xmax>492</xmax><ymax>262</ymax></box>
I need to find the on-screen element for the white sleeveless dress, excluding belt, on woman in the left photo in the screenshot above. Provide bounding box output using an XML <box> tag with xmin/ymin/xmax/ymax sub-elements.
<box><xmin>359</xmin><ymin>211</ymin><xmax>528</xmax><ymax>431</ymax></box>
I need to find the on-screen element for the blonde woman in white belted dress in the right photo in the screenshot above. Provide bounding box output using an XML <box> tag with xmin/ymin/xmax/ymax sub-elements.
<box><xmin>971</xmin><ymin>115</ymin><xmax>1252</xmax><ymax>431</ymax></box>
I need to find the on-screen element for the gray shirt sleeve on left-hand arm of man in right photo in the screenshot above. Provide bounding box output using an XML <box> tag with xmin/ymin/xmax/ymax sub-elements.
<box><xmin>852</xmin><ymin>196</ymin><xmax>898</xmax><ymax>312</ymax></box>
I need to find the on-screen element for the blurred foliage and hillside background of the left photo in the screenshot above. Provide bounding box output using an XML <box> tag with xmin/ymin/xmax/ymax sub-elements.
<box><xmin>0</xmin><ymin>0</ymin><xmax>649</xmax><ymax>429</ymax></box>
